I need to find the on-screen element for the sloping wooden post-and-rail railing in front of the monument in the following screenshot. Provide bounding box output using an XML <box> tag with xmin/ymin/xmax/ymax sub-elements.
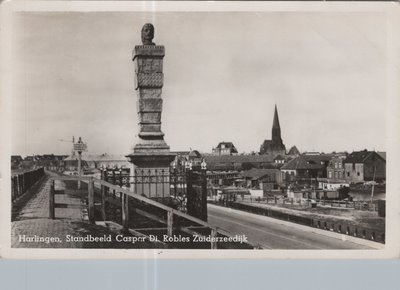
<box><xmin>49</xmin><ymin>176</ymin><xmax>253</xmax><ymax>249</ymax></box>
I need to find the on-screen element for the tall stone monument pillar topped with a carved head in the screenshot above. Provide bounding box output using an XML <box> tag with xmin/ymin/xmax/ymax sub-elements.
<box><xmin>126</xmin><ymin>23</ymin><xmax>175</xmax><ymax>198</ymax></box>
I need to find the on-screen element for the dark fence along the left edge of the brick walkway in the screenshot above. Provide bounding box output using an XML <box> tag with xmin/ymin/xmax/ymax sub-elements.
<box><xmin>11</xmin><ymin>167</ymin><xmax>44</xmax><ymax>202</ymax></box>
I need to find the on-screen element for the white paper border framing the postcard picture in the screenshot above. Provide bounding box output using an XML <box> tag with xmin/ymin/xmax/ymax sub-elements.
<box><xmin>0</xmin><ymin>1</ymin><xmax>400</xmax><ymax>259</ymax></box>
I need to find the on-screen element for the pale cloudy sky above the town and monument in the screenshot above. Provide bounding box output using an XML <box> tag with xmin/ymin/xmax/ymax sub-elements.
<box><xmin>11</xmin><ymin>12</ymin><xmax>387</xmax><ymax>155</ymax></box>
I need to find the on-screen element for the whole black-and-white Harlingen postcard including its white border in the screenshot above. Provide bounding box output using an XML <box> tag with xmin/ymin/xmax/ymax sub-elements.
<box><xmin>1</xmin><ymin>2</ymin><xmax>399</xmax><ymax>258</ymax></box>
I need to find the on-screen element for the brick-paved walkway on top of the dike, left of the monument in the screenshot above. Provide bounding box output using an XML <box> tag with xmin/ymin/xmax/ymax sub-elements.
<box><xmin>11</xmin><ymin>172</ymin><xmax>157</xmax><ymax>249</ymax></box>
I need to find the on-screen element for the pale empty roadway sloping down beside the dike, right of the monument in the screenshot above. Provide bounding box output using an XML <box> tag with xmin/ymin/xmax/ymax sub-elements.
<box><xmin>208</xmin><ymin>204</ymin><xmax>383</xmax><ymax>249</ymax></box>
